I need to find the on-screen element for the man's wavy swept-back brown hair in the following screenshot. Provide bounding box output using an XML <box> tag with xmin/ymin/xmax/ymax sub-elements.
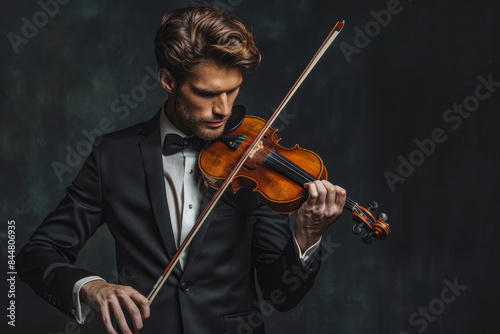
<box><xmin>155</xmin><ymin>6</ymin><xmax>260</xmax><ymax>82</ymax></box>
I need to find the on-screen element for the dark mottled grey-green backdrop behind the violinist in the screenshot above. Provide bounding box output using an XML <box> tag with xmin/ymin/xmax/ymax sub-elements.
<box><xmin>0</xmin><ymin>0</ymin><xmax>500</xmax><ymax>334</ymax></box>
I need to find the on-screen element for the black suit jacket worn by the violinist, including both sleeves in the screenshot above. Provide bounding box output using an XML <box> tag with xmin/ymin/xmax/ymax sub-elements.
<box><xmin>18</xmin><ymin>113</ymin><xmax>319</xmax><ymax>333</ymax></box>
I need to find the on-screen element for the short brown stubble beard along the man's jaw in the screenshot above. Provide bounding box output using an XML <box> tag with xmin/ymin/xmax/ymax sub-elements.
<box><xmin>174</xmin><ymin>92</ymin><xmax>229</xmax><ymax>141</ymax></box>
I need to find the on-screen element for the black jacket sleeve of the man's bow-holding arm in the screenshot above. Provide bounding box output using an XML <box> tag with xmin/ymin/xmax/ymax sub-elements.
<box><xmin>17</xmin><ymin>146</ymin><xmax>103</xmax><ymax>316</ymax></box>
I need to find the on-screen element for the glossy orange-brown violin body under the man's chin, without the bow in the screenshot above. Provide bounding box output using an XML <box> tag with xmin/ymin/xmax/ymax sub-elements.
<box><xmin>198</xmin><ymin>116</ymin><xmax>327</xmax><ymax>213</ymax></box>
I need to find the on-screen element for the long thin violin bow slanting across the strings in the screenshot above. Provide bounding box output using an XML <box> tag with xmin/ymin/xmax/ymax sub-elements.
<box><xmin>148</xmin><ymin>21</ymin><xmax>344</xmax><ymax>304</ymax></box>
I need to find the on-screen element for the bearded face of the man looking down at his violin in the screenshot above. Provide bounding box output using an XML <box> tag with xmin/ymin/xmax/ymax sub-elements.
<box><xmin>167</xmin><ymin>64</ymin><xmax>243</xmax><ymax>141</ymax></box>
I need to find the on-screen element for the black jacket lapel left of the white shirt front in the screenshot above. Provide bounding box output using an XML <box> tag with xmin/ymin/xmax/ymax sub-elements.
<box><xmin>139</xmin><ymin>113</ymin><xmax>176</xmax><ymax>259</ymax></box>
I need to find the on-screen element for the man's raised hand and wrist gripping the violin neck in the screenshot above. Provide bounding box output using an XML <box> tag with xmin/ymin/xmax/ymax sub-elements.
<box><xmin>295</xmin><ymin>180</ymin><xmax>346</xmax><ymax>252</ymax></box>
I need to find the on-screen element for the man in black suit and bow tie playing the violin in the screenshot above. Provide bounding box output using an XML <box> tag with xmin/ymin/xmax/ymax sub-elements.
<box><xmin>18</xmin><ymin>6</ymin><xmax>345</xmax><ymax>333</ymax></box>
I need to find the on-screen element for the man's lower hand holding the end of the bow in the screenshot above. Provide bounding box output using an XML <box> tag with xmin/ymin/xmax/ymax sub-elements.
<box><xmin>80</xmin><ymin>280</ymin><xmax>149</xmax><ymax>334</ymax></box>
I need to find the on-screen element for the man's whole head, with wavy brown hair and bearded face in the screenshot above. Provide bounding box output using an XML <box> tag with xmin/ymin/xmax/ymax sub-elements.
<box><xmin>155</xmin><ymin>6</ymin><xmax>260</xmax><ymax>140</ymax></box>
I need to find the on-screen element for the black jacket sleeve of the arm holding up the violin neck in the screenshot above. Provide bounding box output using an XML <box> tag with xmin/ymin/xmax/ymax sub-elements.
<box><xmin>252</xmin><ymin>205</ymin><xmax>321</xmax><ymax>311</ymax></box>
